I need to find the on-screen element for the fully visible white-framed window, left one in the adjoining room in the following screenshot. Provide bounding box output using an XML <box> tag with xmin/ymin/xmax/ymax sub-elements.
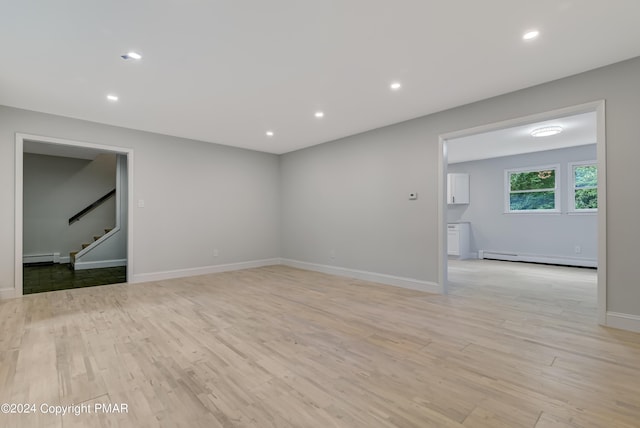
<box><xmin>505</xmin><ymin>165</ymin><xmax>560</xmax><ymax>213</ymax></box>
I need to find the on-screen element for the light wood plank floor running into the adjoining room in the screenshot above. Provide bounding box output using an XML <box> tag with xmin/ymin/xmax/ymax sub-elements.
<box><xmin>0</xmin><ymin>261</ymin><xmax>640</xmax><ymax>428</ymax></box>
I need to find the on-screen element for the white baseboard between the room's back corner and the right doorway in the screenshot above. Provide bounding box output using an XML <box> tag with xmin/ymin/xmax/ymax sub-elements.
<box><xmin>281</xmin><ymin>259</ymin><xmax>442</xmax><ymax>294</ymax></box>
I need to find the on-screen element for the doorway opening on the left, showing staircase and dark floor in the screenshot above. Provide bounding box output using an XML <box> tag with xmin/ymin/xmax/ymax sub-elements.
<box><xmin>13</xmin><ymin>134</ymin><xmax>133</xmax><ymax>297</ymax></box>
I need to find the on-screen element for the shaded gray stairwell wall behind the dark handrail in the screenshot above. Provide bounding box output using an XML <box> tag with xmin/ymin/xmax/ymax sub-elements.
<box><xmin>23</xmin><ymin>153</ymin><xmax>116</xmax><ymax>257</ymax></box>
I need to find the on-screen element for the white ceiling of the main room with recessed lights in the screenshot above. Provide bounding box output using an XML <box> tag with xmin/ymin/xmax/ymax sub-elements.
<box><xmin>0</xmin><ymin>0</ymin><xmax>640</xmax><ymax>153</ymax></box>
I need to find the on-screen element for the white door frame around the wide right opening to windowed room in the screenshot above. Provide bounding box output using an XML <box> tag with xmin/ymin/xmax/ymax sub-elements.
<box><xmin>438</xmin><ymin>100</ymin><xmax>607</xmax><ymax>325</ymax></box>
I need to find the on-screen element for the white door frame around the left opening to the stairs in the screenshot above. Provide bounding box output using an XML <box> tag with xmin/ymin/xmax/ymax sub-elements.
<box><xmin>13</xmin><ymin>133</ymin><xmax>134</xmax><ymax>297</ymax></box>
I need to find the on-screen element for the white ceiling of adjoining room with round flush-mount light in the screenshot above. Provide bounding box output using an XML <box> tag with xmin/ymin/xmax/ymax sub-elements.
<box><xmin>447</xmin><ymin>112</ymin><xmax>597</xmax><ymax>164</ymax></box>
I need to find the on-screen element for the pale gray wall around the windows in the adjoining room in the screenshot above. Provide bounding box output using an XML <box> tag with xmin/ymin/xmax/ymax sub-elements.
<box><xmin>447</xmin><ymin>144</ymin><xmax>598</xmax><ymax>261</ymax></box>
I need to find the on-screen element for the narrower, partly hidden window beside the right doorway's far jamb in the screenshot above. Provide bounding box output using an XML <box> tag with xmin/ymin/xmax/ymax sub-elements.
<box><xmin>569</xmin><ymin>161</ymin><xmax>598</xmax><ymax>212</ymax></box>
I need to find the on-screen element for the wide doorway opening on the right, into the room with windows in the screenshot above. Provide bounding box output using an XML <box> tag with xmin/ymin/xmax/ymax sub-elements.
<box><xmin>439</xmin><ymin>101</ymin><xmax>606</xmax><ymax>324</ymax></box>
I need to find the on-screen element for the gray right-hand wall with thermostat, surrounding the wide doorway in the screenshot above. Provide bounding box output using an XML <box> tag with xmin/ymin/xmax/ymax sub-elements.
<box><xmin>281</xmin><ymin>58</ymin><xmax>640</xmax><ymax>315</ymax></box>
